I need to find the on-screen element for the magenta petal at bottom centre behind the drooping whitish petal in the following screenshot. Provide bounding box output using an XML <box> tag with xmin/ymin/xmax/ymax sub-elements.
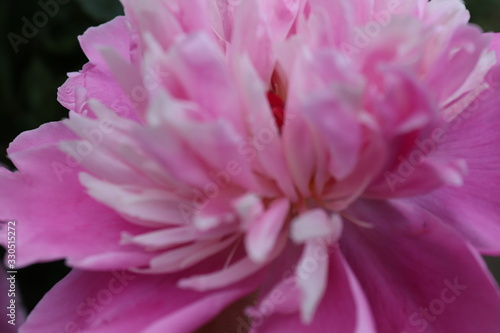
<box><xmin>251</xmin><ymin>247</ymin><xmax>374</xmax><ymax>333</ymax></box>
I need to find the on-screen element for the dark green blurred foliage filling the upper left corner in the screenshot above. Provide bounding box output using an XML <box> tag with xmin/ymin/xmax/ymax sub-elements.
<box><xmin>0</xmin><ymin>0</ymin><xmax>123</xmax><ymax>169</ymax></box>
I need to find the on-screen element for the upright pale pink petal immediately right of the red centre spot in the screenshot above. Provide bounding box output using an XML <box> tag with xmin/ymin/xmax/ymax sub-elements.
<box><xmin>283</xmin><ymin>47</ymin><xmax>362</xmax><ymax>196</ymax></box>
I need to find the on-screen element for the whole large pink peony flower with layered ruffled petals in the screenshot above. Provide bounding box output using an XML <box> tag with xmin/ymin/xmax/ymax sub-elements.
<box><xmin>0</xmin><ymin>0</ymin><xmax>500</xmax><ymax>333</ymax></box>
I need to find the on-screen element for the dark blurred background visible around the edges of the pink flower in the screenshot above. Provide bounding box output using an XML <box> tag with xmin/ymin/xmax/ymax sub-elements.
<box><xmin>0</xmin><ymin>0</ymin><xmax>500</xmax><ymax>310</ymax></box>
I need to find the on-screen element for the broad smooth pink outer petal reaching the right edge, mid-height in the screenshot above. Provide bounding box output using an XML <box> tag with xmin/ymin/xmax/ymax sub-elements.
<box><xmin>409</xmin><ymin>67</ymin><xmax>500</xmax><ymax>254</ymax></box>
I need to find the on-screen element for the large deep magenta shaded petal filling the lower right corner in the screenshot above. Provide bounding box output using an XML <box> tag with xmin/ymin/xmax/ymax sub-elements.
<box><xmin>341</xmin><ymin>201</ymin><xmax>500</xmax><ymax>333</ymax></box>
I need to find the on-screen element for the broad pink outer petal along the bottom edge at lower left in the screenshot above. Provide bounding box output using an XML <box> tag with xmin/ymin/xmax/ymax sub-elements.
<box><xmin>20</xmin><ymin>270</ymin><xmax>256</xmax><ymax>333</ymax></box>
